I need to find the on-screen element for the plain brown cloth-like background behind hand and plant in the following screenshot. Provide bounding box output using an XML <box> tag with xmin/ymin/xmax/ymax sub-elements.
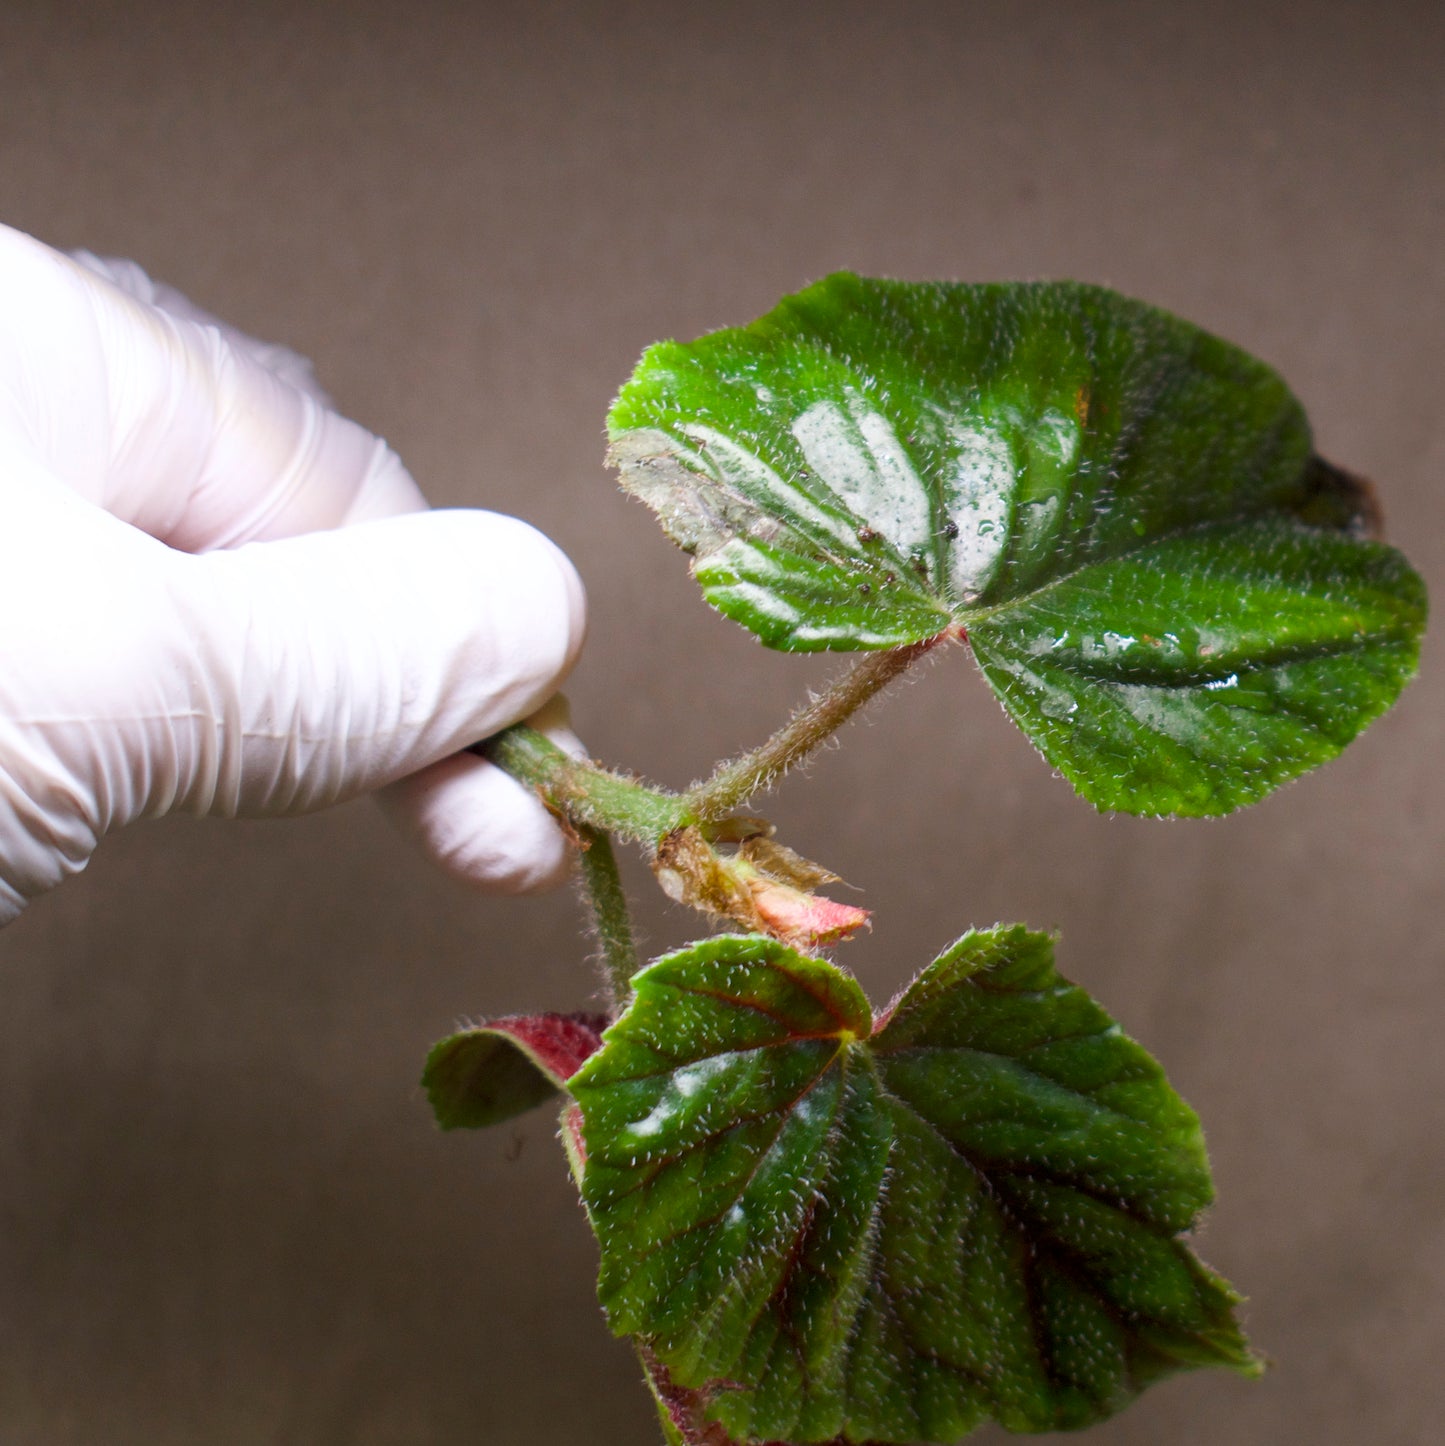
<box><xmin>0</xmin><ymin>0</ymin><xmax>1445</xmax><ymax>1446</ymax></box>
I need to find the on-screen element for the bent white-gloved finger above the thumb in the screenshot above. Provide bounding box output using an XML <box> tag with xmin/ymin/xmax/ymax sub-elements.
<box><xmin>0</xmin><ymin>227</ymin><xmax>425</xmax><ymax>552</ymax></box>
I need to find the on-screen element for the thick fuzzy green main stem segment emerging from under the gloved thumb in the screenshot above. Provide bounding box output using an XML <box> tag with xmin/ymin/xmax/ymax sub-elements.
<box><xmin>482</xmin><ymin>723</ymin><xmax>693</xmax><ymax>849</ymax></box>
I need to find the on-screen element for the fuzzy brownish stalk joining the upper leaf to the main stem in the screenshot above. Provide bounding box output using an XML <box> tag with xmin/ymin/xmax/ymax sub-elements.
<box><xmin>683</xmin><ymin>629</ymin><xmax>955</xmax><ymax>823</ymax></box>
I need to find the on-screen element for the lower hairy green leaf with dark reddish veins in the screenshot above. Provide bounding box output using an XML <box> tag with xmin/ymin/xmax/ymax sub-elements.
<box><xmin>568</xmin><ymin>928</ymin><xmax>1256</xmax><ymax>1443</ymax></box>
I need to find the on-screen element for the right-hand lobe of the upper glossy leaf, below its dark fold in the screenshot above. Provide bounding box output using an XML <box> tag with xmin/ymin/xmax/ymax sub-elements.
<box><xmin>969</xmin><ymin>518</ymin><xmax>1425</xmax><ymax>816</ymax></box>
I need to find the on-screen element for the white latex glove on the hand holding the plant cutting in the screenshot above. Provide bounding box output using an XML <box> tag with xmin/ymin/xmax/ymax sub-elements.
<box><xmin>0</xmin><ymin>227</ymin><xmax>584</xmax><ymax>923</ymax></box>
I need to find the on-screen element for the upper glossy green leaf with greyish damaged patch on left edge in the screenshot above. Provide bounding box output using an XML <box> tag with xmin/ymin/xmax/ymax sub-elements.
<box><xmin>608</xmin><ymin>273</ymin><xmax>1425</xmax><ymax>814</ymax></box>
